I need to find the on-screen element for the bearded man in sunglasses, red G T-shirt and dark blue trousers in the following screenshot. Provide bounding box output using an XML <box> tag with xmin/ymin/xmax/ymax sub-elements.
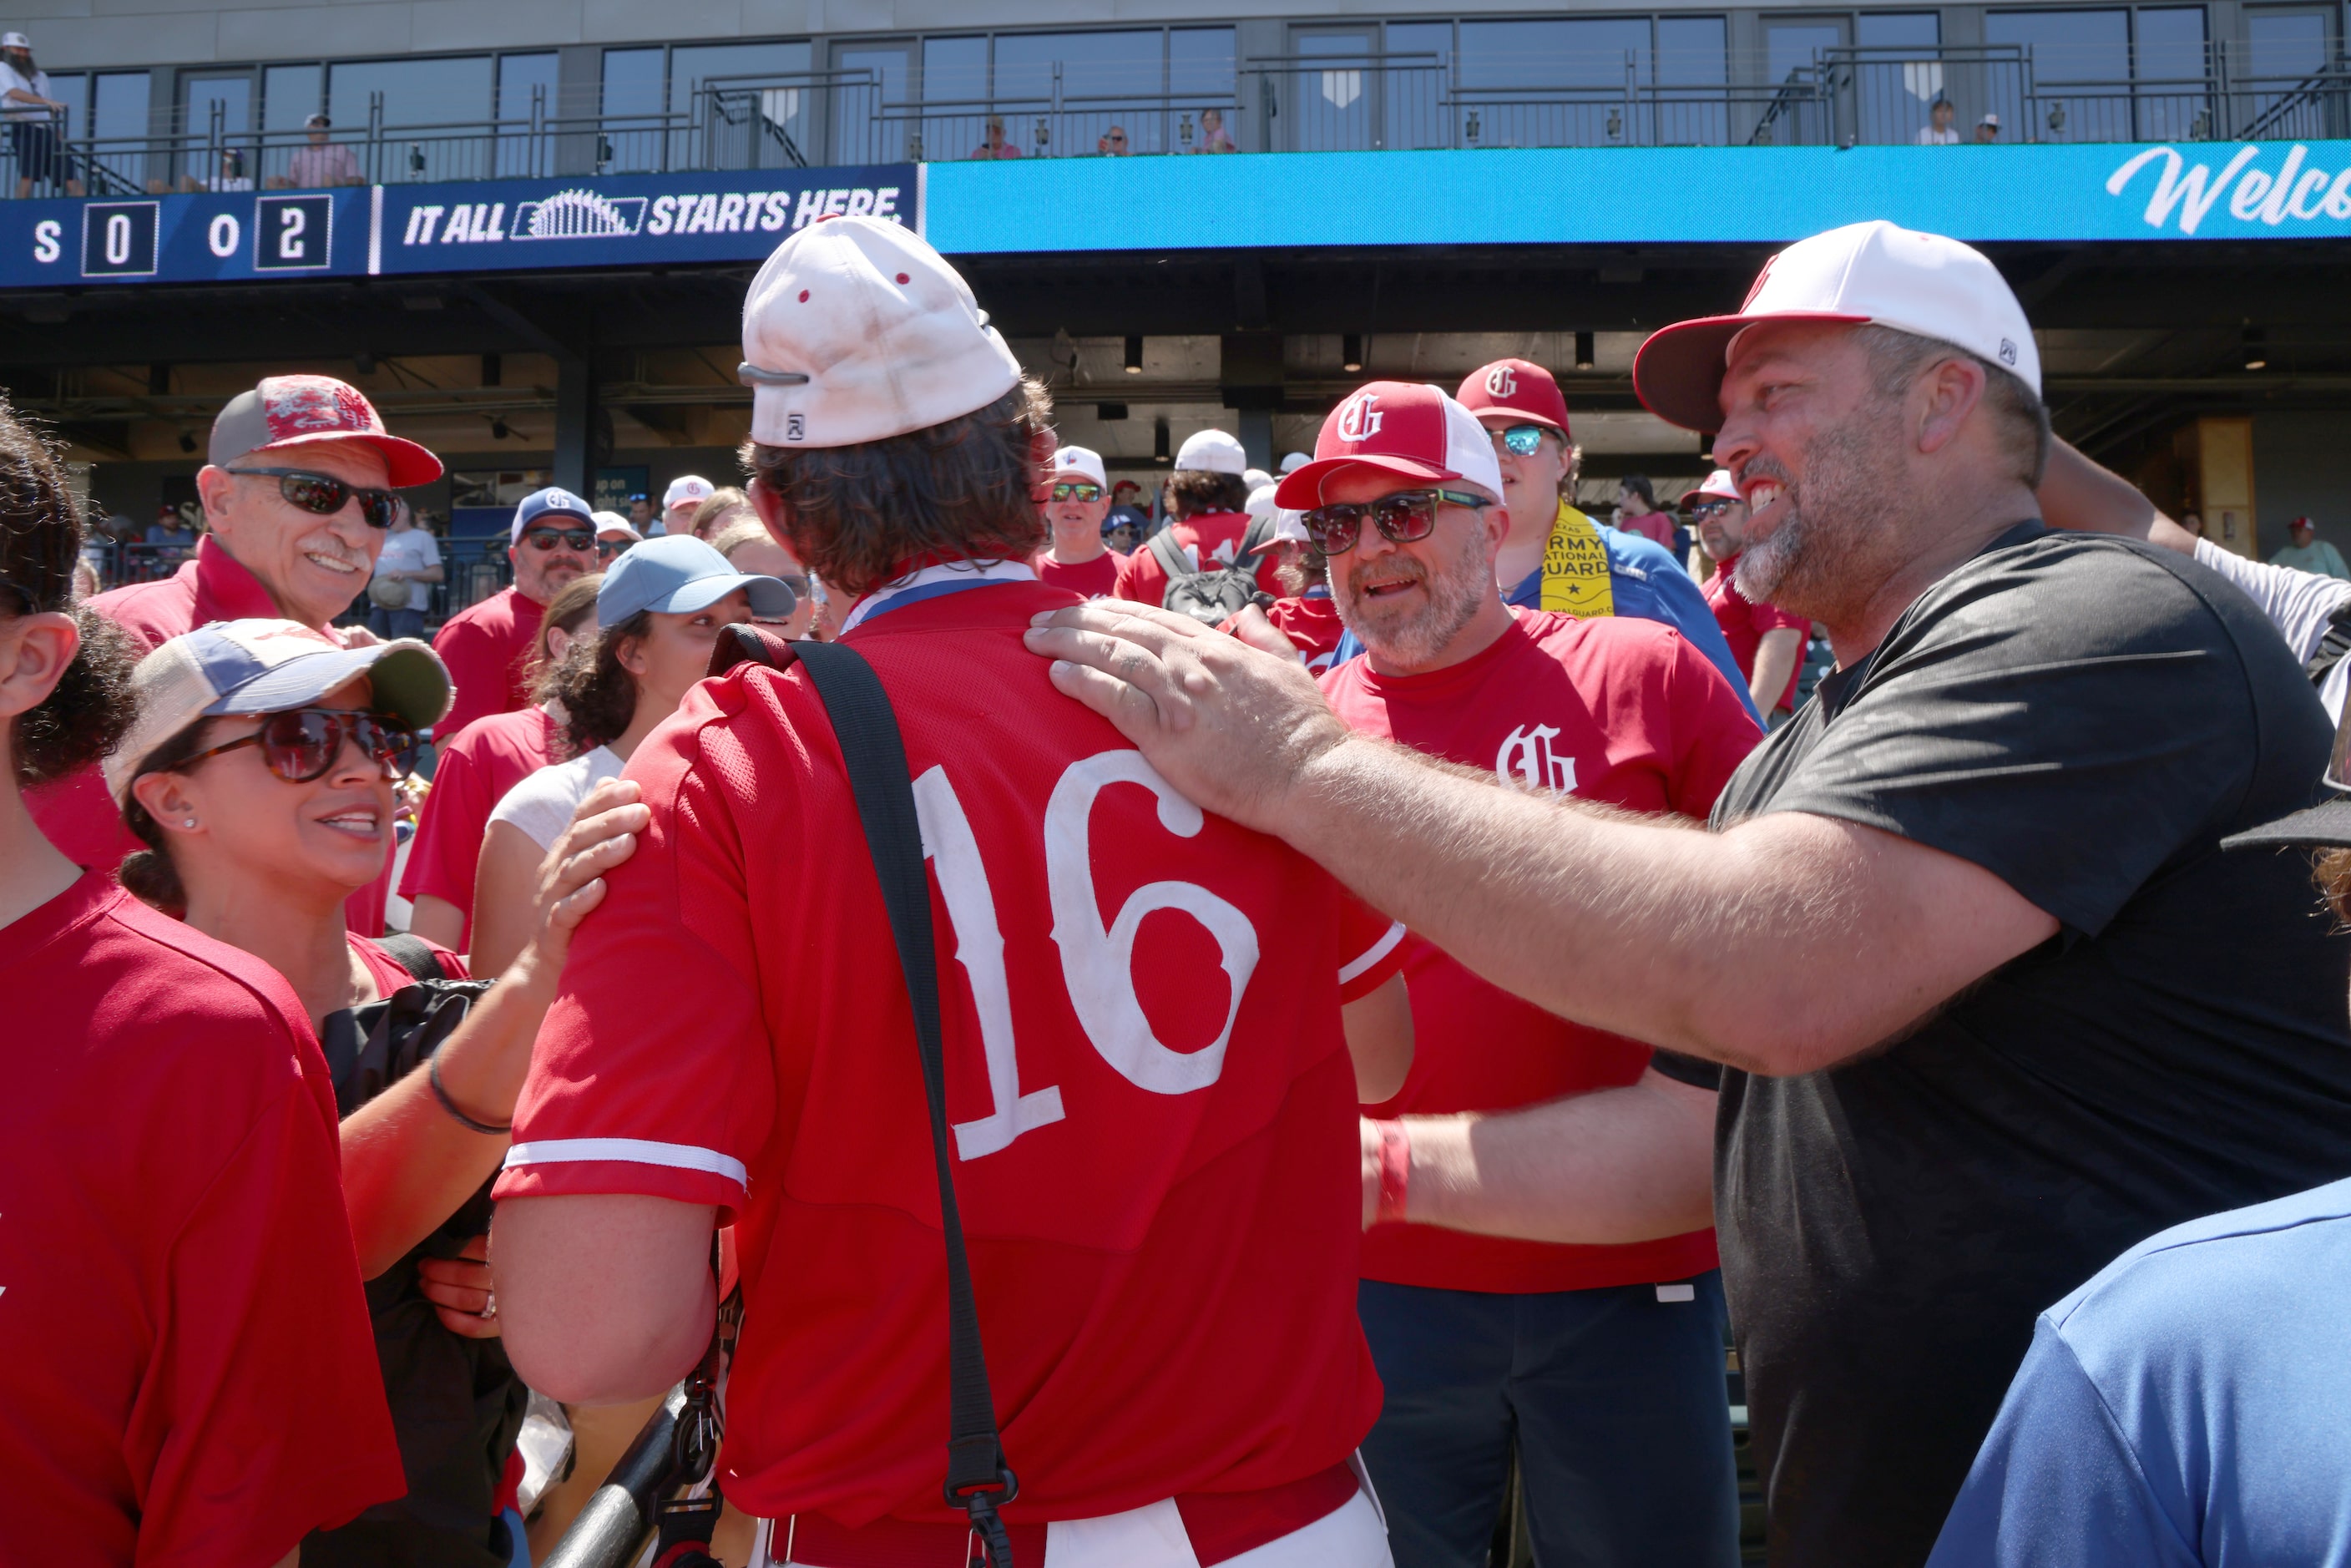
<box><xmin>1277</xmin><ymin>381</ymin><xmax>1758</xmax><ymax>1568</ymax></box>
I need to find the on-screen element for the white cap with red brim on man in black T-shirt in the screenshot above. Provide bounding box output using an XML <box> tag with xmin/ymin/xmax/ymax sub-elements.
<box><xmin>1631</xmin><ymin>219</ymin><xmax>2040</xmax><ymax>430</ymax></box>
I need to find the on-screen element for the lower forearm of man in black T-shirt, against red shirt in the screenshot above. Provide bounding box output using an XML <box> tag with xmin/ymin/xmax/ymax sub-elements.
<box><xmin>1403</xmin><ymin>1072</ymin><xmax>1714</xmax><ymax>1246</ymax></box>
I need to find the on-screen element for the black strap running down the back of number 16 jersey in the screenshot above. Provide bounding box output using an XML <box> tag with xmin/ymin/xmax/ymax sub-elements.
<box><xmin>792</xmin><ymin>642</ymin><xmax>1020</xmax><ymax>1568</ymax></box>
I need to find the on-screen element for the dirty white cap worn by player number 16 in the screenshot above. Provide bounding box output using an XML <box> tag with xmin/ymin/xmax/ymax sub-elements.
<box><xmin>738</xmin><ymin>216</ymin><xmax>1020</xmax><ymax>447</ymax></box>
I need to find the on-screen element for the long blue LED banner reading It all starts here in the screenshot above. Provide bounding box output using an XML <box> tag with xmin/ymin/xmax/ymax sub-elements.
<box><xmin>0</xmin><ymin>141</ymin><xmax>2351</xmax><ymax>289</ymax></box>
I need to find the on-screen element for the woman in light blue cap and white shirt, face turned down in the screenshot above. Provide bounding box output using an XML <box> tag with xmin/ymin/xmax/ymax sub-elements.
<box><xmin>470</xmin><ymin>534</ymin><xmax>795</xmax><ymax>975</ymax></box>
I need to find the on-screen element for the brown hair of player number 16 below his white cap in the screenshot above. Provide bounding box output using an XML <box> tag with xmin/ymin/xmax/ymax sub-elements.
<box><xmin>743</xmin><ymin>376</ymin><xmax>1054</xmax><ymax>599</ymax></box>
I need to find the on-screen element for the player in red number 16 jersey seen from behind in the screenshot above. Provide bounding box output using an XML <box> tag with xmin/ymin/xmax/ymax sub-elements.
<box><xmin>493</xmin><ymin>219</ymin><xmax>1411</xmax><ymax>1568</ymax></box>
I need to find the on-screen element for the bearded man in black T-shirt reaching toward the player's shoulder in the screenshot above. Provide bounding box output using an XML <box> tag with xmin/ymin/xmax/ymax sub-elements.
<box><xmin>1029</xmin><ymin>223</ymin><xmax>2351</xmax><ymax>1568</ymax></box>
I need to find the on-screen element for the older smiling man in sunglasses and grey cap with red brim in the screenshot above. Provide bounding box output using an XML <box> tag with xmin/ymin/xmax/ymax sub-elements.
<box><xmin>26</xmin><ymin>376</ymin><xmax>442</xmax><ymax>933</ymax></box>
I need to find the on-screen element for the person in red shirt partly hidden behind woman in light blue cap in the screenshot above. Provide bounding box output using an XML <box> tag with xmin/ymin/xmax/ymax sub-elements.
<box><xmin>400</xmin><ymin>574</ymin><xmax>604</xmax><ymax>952</ymax></box>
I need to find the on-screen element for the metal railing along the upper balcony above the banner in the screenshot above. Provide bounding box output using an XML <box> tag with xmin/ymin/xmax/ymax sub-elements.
<box><xmin>0</xmin><ymin>44</ymin><xmax>2351</xmax><ymax>195</ymax></box>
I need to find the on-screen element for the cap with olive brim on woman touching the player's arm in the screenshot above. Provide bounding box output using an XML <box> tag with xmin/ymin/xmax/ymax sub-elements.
<box><xmin>106</xmin><ymin>620</ymin><xmax>453</xmax><ymax>807</ymax></box>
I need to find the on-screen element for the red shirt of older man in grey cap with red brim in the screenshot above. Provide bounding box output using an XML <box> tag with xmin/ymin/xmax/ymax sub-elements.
<box><xmin>23</xmin><ymin>534</ymin><xmax>392</xmax><ymax>933</ymax></box>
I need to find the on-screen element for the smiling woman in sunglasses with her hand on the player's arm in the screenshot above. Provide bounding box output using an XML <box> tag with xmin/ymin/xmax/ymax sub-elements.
<box><xmin>106</xmin><ymin>620</ymin><xmax>645</xmax><ymax>1568</ymax></box>
